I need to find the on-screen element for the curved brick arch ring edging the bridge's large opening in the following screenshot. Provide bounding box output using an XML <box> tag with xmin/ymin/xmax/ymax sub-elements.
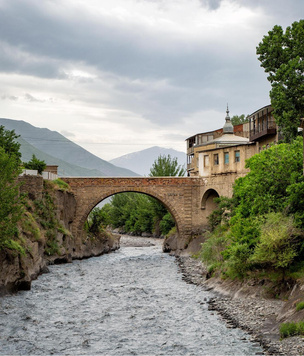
<box><xmin>78</xmin><ymin>188</ymin><xmax>181</xmax><ymax>233</ymax></box>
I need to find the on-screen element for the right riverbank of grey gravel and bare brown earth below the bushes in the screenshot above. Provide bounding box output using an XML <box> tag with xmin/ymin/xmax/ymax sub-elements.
<box><xmin>177</xmin><ymin>257</ymin><xmax>304</xmax><ymax>355</ymax></box>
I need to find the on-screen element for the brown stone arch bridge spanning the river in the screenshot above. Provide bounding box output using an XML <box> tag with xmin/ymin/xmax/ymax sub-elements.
<box><xmin>62</xmin><ymin>177</ymin><xmax>233</xmax><ymax>250</ymax></box>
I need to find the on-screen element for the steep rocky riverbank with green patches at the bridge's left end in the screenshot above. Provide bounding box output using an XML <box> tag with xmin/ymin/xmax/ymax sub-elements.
<box><xmin>0</xmin><ymin>176</ymin><xmax>120</xmax><ymax>295</ymax></box>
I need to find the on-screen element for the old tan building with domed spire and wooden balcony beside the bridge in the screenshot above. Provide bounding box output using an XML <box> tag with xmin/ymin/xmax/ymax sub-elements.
<box><xmin>187</xmin><ymin>105</ymin><xmax>279</xmax><ymax>196</ymax></box>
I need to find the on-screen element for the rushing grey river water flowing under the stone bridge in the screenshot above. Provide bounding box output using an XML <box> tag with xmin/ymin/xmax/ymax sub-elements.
<box><xmin>0</xmin><ymin>236</ymin><xmax>262</xmax><ymax>356</ymax></box>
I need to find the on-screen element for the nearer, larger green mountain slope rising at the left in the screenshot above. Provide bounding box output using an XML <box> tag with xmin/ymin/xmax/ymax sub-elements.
<box><xmin>0</xmin><ymin>118</ymin><xmax>138</xmax><ymax>177</ymax></box>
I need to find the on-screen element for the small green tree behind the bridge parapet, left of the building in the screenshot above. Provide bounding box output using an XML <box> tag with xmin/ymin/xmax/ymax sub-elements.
<box><xmin>149</xmin><ymin>155</ymin><xmax>186</xmax><ymax>177</ymax></box>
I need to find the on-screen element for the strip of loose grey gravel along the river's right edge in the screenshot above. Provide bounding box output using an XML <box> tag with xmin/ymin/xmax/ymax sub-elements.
<box><xmin>177</xmin><ymin>257</ymin><xmax>304</xmax><ymax>355</ymax></box>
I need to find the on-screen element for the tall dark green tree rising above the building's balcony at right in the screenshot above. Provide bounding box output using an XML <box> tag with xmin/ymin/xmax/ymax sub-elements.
<box><xmin>257</xmin><ymin>20</ymin><xmax>304</xmax><ymax>142</ymax></box>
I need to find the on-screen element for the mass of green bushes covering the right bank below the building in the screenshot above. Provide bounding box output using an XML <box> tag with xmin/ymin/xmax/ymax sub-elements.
<box><xmin>200</xmin><ymin>138</ymin><xmax>304</xmax><ymax>280</ymax></box>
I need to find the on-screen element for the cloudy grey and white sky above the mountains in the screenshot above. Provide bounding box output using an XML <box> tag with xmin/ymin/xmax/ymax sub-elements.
<box><xmin>0</xmin><ymin>0</ymin><xmax>304</xmax><ymax>160</ymax></box>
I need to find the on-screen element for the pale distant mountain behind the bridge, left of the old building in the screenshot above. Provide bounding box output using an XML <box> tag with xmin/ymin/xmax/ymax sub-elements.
<box><xmin>110</xmin><ymin>146</ymin><xmax>186</xmax><ymax>176</ymax></box>
